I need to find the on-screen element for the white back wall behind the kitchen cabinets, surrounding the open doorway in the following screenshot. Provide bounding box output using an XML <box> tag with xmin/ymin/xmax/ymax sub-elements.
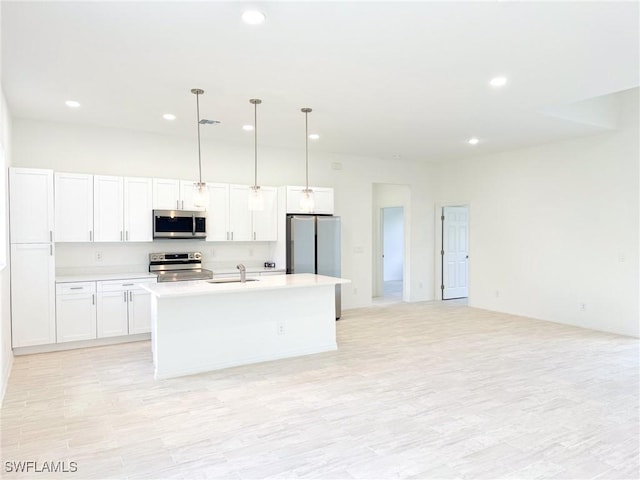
<box><xmin>13</xmin><ymin>119</ymin><xmax>434</xmax><ymax>308</ymax></box>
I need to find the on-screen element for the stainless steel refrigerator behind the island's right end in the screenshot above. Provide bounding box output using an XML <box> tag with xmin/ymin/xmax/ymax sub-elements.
<box><xmin>287</xmin><ymin>215</ymin><xmax>342</xmax><ymax>320</ymax></box>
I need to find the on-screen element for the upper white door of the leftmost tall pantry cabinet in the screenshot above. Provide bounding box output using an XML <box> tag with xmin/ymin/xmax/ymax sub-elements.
<box><xmin>9</xmin><ymin>168</ymin><xmax>54</xmax><ymax>243</ymax></box>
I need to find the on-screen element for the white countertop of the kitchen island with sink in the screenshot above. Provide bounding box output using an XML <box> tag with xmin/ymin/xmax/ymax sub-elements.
<box><xmin>141</xmin><ymin>273</ymin><xmax>351</xmax><ymax>298</ymax></box>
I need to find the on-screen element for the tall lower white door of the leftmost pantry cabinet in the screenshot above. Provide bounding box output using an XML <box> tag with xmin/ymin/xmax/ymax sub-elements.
<box><xmin>11</xmin><ymin>244</ymin><xmax>56</xmax><ymax>348</ymax></box>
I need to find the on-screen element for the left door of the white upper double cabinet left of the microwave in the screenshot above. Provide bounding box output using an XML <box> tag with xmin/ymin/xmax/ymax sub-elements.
<box><xmin>93</xmin><ymin>175</ymin><xmax>124</xmax><ymax>242</ymax></box>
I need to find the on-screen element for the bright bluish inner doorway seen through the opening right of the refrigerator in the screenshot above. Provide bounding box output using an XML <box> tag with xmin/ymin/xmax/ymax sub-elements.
<box><xmin>380</xmin><ymin>207</ymin><xmax>404</xmax><ymax>300</ymax></box>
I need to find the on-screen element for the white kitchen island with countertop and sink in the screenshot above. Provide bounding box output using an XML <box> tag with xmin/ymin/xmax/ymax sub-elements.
<box><xmin>143</xmin><ymin>273</ymin><xmax>349</xmax><ymax>379</ymax></box>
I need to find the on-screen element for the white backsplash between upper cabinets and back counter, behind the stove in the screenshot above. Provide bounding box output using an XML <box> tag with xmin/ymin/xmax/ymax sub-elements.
<box><xmin>55</xmin><ymin>240</ymin><xmax>276</xmax><ymax>275</ymax></box>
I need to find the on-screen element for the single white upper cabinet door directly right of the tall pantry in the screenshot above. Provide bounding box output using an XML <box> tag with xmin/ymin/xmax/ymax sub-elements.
<box><xmin>55</xmin><ymin>172</ymin><xmax>93</xmax><ymax>242</ymax></box>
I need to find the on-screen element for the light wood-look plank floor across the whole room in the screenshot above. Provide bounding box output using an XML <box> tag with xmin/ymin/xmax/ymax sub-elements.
<box><xmin>0</xmin><ymin>303</ymin><xmax>640</xmax><ymax>480</ymax></box>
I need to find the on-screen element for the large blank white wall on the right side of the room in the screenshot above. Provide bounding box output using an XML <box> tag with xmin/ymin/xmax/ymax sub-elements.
<box><xmin>434</xmin><ymin>89</ymin><xmax>640</xmax><ymax>336</ymax></box>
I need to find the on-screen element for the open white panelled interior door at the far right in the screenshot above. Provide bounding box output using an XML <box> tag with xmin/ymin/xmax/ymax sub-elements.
<box><xmin>441</xmin><ymin>206</ymin><xmax>469</xmax><ymax>300</ymax></box>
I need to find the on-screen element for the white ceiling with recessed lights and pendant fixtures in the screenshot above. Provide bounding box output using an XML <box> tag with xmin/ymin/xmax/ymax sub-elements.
<box><xmin>1</xmin><ymin>1</ymin><xmax>640</xmax><ymax>161</ymax></box>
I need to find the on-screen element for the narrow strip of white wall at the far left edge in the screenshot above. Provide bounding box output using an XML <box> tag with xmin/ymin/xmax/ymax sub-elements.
<box><xmin>0</xmin><ymin>87</ymin><xmax>13</xmax><ymax>401</ymax></box>
